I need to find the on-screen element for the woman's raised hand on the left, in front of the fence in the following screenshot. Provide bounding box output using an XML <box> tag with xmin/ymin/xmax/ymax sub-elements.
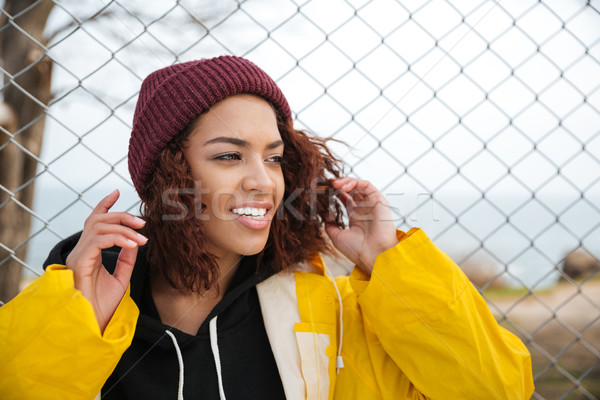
<box><xmin>67</xmin><ymin>190</ymin><xmax>148</xmax><ymax>333</ymax></box>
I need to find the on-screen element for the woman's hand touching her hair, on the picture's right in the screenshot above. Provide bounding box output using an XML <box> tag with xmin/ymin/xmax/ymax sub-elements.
<box><xmin>325</xmin><ymin>177</ymin><xmax>398</xmax><ymax>276</ymax></box>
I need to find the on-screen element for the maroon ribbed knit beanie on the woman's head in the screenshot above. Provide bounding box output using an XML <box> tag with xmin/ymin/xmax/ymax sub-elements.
<box><xmin>128</xmin><ymin>56</ymin><xmax>292</xmax><ymax>196</ymax></box>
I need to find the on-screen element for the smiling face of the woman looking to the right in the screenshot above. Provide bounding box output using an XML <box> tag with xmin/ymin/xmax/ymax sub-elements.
<box><xmin>183</xmin><ymin>94</ymin><xmax>284</xmax><ymax>265</ymax></box>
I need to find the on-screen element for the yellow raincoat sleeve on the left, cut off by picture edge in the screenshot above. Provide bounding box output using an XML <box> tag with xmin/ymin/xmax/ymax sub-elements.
<box><xmin>0</xmin><ymin>265</ymin><xmax>139</xmax><ymax>400</ymax></box>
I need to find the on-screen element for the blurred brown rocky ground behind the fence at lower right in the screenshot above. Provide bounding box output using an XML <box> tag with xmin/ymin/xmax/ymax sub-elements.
<box><xmin>485</xmin><ymin>279</ymin><xmax>600</xmax><ymax>399</ymax></box>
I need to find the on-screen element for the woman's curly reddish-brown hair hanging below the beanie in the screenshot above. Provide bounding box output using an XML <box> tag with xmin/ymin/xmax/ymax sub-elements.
<box><xmin>141</xmin><ymin>109</ymin><xmax>344</xmax><ymax>293</ymax></box>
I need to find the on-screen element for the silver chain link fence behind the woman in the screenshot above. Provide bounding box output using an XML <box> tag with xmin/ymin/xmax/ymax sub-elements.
<box><xmin>0</xmin><ymin>0</ymin><xmax>600</xmax><ymax>399</ymax></box>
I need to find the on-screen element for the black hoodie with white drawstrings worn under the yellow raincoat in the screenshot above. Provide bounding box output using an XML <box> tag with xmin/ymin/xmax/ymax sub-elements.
<box><xmin>44</xmin><ymin>233</ymin><xmax>285</xmax><ymax>400</ymax></box>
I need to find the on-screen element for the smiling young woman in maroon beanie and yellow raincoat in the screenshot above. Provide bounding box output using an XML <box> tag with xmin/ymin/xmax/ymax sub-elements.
<box><xmin>0</xmin><ymin>56</ymin><xmax>533</xmax><ymax>400</ymax></box>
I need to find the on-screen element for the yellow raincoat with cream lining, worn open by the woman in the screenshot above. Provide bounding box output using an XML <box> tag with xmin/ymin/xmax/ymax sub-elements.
<box><xmin>0</xmin><ymin>229</ymin><xmax>533</xmax><ymax>400</ymax></box>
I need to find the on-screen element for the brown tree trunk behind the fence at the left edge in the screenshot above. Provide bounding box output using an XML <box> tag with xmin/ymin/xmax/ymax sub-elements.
<box><xmin>0</xmin><ymin>0</ymin><xmax>54</xmax><ymax>304</ymax></box>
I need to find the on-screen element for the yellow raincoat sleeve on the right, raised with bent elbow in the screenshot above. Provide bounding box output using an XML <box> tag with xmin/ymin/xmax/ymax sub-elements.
<box><xmin>350</xmin><ymin>228</ymin><xmax>533</xmax><ymax>400</ymax></box>
